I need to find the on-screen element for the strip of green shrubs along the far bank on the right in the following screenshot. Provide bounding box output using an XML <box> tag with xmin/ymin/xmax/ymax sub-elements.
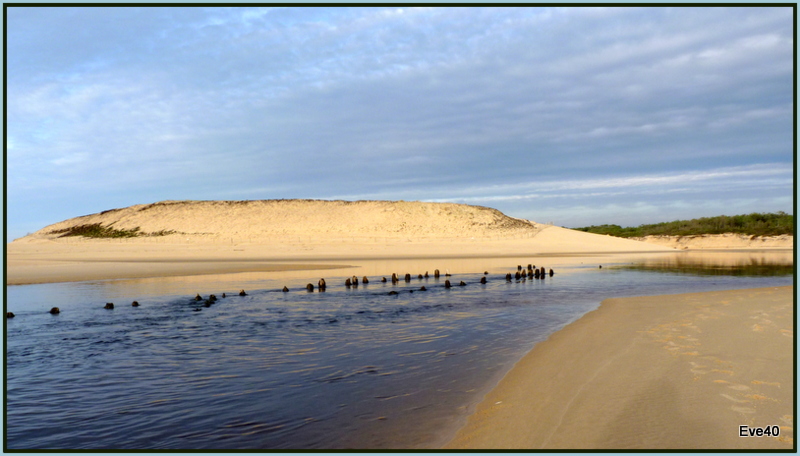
<box><xmin>574</xmin><ymin>211</ymin><xmax>794</xmax><ymax>238</ymax></box>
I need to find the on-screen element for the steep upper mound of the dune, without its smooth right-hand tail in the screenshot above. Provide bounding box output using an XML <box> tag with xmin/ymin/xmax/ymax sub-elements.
<box><xmin>22</xmin><ymin>200</ymin><xmax>543</xmax><ymax>240</ymax></box>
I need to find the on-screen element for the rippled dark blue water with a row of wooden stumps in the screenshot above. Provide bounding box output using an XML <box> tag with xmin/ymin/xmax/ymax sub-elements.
<box><xmin>6</xmin><ymin>252</ymin><xmax>793</xmax><ymax>449</ymax></box>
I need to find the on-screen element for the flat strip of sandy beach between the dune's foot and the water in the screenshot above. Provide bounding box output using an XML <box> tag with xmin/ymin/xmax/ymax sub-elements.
<box><xmin>6</xmin><ymin>235</ymin><xmax>675</xmax><ymax>285</ymax></box>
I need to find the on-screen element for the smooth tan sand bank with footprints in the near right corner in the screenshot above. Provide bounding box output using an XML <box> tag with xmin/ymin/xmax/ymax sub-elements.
<box><xmin>445</xmin><ymin>287</ymin><xmax>794</xmax><ymax>450</ymax></box>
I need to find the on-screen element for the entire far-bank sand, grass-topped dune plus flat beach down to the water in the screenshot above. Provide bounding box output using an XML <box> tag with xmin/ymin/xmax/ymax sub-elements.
<box><xmin>6</xmin><ymin>200</ymin><xmax>673</xmax><ymax>284</ymax></box>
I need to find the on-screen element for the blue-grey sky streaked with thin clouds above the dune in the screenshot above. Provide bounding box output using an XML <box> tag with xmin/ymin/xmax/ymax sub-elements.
<box><xmin>6</xmin><ymin>7</ymin><xmax>794</xmax><ymax>240</ymax></box>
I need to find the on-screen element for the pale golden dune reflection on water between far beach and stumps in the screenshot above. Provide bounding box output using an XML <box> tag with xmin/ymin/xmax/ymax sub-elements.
<box><xmin>6</xmin><ymin>253</ymin><xmax>688</xmax><ymax>312</ymax></box>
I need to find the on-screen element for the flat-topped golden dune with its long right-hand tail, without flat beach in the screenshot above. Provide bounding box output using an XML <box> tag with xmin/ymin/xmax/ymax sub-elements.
<box><xmin>11</xmin><ymin>200</ymin><xmax>671</xmax><ymax>258</ymax></box>
